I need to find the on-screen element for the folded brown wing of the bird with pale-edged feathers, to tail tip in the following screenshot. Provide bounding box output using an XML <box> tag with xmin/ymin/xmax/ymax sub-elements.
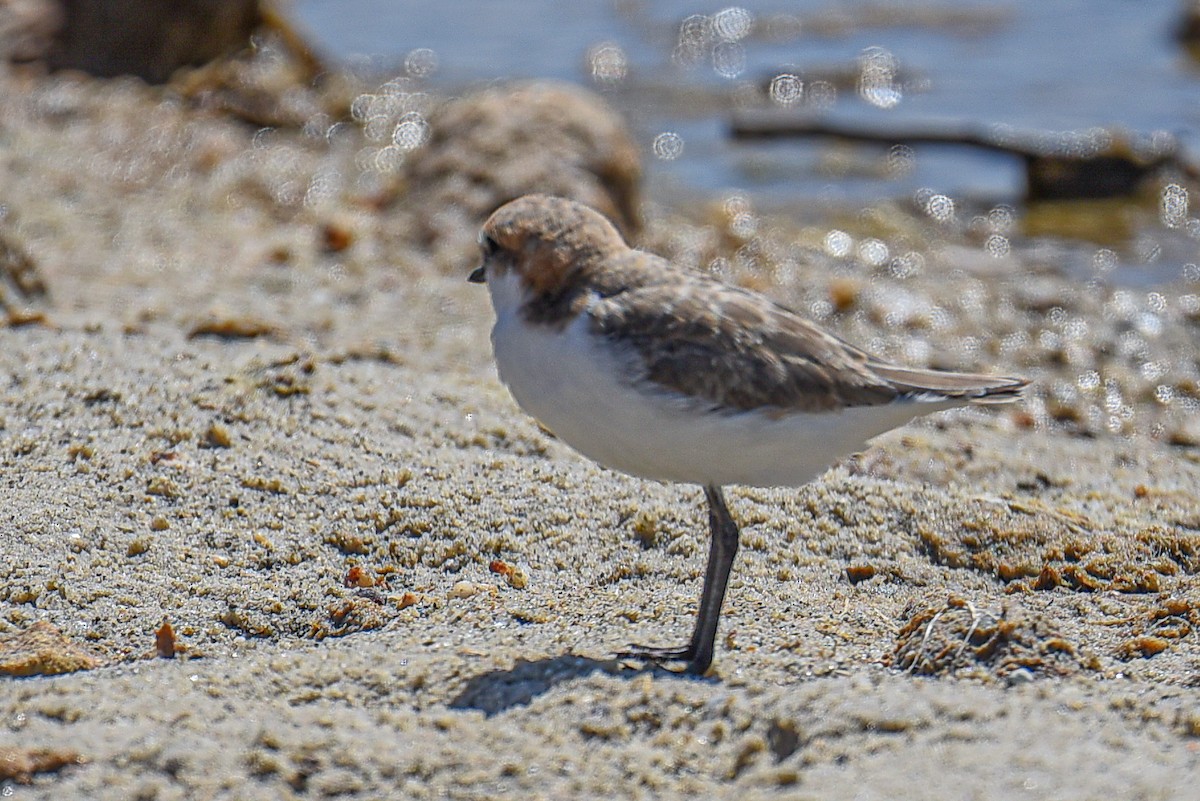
<box><xmin>589</xmin><ymin>273</ymin><xmax>1025</xmax><ymax>412</ymax></box>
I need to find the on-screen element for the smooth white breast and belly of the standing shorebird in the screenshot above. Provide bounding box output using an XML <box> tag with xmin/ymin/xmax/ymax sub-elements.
<box><xmin>492</xmin><ymin>293</ymin><xmax>959</xmax><ymax>487</ymax></box>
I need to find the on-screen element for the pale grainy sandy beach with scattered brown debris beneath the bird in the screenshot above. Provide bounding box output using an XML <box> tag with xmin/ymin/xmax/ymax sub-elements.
<box><xmin>0</xmin><ymin>57</ymin><xmax>1200</xmax><ymax>801</ymax></box>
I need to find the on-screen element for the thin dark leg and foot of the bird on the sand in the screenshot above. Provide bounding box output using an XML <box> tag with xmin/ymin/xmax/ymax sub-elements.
<box><xmin>620</xmin><ymin>487</ymin><xmax>739</xmax><ymax>675</ymax></box>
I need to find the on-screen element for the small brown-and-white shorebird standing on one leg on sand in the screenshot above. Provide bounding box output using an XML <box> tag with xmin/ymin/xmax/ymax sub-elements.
<box><xmin>468</xmin><ymin>194</ymin><xmax>1028</xmax><ymax>675</ymax></box>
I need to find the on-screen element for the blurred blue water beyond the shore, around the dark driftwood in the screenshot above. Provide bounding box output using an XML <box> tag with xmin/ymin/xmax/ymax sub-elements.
<box><xmin>295</xmin><ymin>0</ymin><xmax>1200</xmax><ymax>278</ymax></box>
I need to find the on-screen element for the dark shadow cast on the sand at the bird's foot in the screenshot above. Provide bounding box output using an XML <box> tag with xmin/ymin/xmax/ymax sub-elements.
<box><xmin>450</xmin><ymin>654</ymin><xmax>718</xmax><ymax>717</ymax></box>
